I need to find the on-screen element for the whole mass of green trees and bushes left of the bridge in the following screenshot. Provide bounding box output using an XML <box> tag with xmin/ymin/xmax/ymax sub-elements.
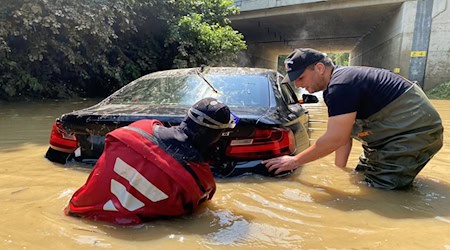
<box><xmin>0</xmin><ymin>0</ymin><xmax>246</xmax><ymax>100</ymax></box>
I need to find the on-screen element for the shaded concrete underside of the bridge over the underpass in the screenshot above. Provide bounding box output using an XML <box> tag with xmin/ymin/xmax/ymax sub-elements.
<box><xmin>230</xmin><ymin>0</ymin><xmax>404</xmax><ymax>54</ymax></box>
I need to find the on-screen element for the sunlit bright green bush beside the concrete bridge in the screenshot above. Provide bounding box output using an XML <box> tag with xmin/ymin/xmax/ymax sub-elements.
<box><xmin>165</xmin><ymin>0</ymin><xmax>246</xmax><ymax>67</ymax></box>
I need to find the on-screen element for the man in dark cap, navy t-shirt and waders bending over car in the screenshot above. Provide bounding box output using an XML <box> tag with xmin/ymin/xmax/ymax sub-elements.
<box><xmin>263</xmin><ymin>49</ymin><xmax>443</xmax><ymax>189</ymax></box>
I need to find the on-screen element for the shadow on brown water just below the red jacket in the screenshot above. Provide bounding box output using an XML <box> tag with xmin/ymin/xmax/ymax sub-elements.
<box><xmin>69</xmin><ymin>203</ymin><xmax>252</xmax><ymax>245</ymax></box>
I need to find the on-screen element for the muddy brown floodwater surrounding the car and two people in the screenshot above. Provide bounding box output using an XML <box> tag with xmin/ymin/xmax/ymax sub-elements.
<box><xmin>0</xmin><ymin>100</ymin><xmax>450</xmax><ymax>250</ymax></box>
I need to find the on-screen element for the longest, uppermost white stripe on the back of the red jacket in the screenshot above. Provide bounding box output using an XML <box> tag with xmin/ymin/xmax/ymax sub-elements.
<box><xmin>114</xmin><ymin>157</ymin><xmax>169</xmax><ymax>202</ymax></box>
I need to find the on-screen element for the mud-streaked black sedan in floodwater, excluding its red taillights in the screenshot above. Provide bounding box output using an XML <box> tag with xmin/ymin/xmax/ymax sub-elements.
<box><xmin>47</xmin><ymin>67</ymin><xmax>309</xmax><ymax>176</ymax></box>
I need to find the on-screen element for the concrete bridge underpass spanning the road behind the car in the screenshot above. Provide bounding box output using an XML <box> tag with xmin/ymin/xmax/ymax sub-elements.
<box><xmin>230</xmin><ymin>0</ymin><xmax>450</xmax><ymax>89</ymax></box>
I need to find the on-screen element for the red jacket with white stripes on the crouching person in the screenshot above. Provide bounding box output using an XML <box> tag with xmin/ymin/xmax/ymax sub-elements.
<box><xmin>65</xmin><ymin>120</ymin><xmax>216</xmax><ymax>224</ymax></box>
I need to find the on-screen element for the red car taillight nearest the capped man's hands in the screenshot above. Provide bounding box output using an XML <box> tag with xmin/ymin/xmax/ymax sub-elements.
<box><xmin>225</xmin><ymin>128</ymin><xmax>295</xmax><ymax>160</ymax></box>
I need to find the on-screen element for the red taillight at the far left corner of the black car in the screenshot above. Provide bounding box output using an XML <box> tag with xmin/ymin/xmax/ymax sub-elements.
<box><xmin>50</xmin><ymin>122</ymin><xmax>78</xmax><ymax>153</ymax></box>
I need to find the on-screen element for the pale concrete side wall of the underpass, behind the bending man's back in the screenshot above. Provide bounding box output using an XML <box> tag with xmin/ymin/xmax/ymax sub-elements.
<box><xmin>350</xmin><ymin>0</ymin><xmax>450</xmax><ymax>90</ymax></box>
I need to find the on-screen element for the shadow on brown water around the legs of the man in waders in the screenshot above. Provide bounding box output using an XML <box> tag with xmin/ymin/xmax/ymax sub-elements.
<box><xmin>297</xmin><ymin>174</ymin><xmax>450</xmax><ymax>219</ymax></box>
